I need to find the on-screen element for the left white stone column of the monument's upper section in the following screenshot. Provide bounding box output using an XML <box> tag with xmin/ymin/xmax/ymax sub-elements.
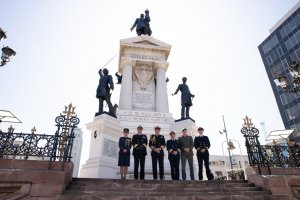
<box><xmin>119</xmin><ymin>59</ymin><xmax>135</xmax><ymax>110</ymax></box>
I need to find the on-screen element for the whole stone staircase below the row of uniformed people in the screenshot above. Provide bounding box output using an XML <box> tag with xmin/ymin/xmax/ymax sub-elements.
<box><xmin>56</xmin><ymin>178</ymin><xmax>273</xmax><ymax>200</ymax></box>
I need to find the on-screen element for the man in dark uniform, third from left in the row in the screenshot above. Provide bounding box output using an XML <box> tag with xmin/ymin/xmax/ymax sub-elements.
<box><xmin>149</xmin><ymin>126</ymin><xmax>166</xmax><ymax>180</ymax></box>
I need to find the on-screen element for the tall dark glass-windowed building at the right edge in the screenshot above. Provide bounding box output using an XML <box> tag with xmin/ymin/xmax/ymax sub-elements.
<box><xmin>258</xmin><ymin>2</ymin><xmax>300</xmax><ymax>131</ymax></box>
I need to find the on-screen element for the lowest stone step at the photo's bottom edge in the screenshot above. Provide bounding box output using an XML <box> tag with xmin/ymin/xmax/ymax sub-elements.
<box><xmin>56</xmin><ymin>194</ymin><xmax>273</xmax><ymax>200</ymax></box>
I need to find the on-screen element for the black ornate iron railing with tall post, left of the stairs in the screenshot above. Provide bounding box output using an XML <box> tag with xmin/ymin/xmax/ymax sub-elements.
<box><xmin>0</xmin><ymin>104</ymin><xmax>79</xmax><ymax>169</ymax></box>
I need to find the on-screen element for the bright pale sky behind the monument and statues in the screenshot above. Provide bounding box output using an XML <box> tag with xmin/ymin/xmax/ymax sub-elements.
<box><xmin>0</xmin><ymin>0</ymin><xmax>298</xmax><ymax>170</ymax></box>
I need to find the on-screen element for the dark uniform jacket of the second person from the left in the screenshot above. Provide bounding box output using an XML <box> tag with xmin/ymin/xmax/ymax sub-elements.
<box><xmin>132</xmin><ymin>134</ymin><xmax>148</xmax><ymax>156</ymax></box>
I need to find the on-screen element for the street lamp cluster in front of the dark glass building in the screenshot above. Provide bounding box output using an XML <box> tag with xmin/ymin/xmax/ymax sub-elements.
<box><xmin>274</xmin><ymin>61</ymin><xmax>300</xmax><ymax>93</ymax></box>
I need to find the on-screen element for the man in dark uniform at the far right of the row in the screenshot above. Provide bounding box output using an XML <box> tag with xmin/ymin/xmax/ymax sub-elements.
<box><xmin>194</xmin><ymin>127</ymin><xmax>213</xmax><ymax>180</ymax></box>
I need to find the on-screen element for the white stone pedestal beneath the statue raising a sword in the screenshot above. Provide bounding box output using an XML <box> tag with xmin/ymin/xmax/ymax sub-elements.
<box><xmin>80</xmin><ymin>114</ymin><xmax>122</xmax><ymax>178</ymax></box>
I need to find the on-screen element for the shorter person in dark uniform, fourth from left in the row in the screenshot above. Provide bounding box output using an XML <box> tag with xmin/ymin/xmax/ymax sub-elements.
<box><xmin>167</xmin><ymin>131</ymin><xmax>180</xmax><ymax>180</ymax></box>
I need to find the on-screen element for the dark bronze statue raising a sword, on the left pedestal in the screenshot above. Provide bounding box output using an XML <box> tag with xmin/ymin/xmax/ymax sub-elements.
<box><xmin>95</xmin><ymin>68</ymin><xmax>115</xmax><ymax>117</ymax></box>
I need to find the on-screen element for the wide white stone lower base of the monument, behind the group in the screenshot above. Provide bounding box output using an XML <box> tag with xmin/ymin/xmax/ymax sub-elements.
<box><xmin>80</xmin><ymin>114</ymin><xmax>202</xmax><ymax>180</ymax></box>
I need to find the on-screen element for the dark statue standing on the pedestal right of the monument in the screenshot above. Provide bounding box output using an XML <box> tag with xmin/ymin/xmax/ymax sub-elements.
<box><xmin>172</xmin><ymin>77</ymin><xmax>195</xmax><ymax>119</ymax></box>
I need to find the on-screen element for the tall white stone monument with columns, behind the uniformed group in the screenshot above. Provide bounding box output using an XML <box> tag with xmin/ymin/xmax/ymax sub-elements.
<box><xmin>80</xmin><ymin>10</ymin><xmax>197</xmax><ymax>179</ymax></box>
